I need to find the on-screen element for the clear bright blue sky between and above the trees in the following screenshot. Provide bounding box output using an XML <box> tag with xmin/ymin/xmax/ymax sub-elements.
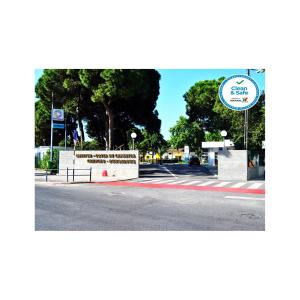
<box><xmin>35</xmin><ymin>69</ymin><xmax>265</xmax><ymax>139</ymax></box>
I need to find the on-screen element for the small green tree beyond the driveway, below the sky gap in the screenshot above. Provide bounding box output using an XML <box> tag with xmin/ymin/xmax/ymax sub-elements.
<box><xmin>169</xmin><ymin>116</ymin><xmax>204</xmax><ymax>152</ymax></box>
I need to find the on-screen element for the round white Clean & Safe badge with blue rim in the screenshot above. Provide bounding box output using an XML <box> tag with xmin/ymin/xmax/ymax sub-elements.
<box><xmin>219</xmin><ymin>75</ymin><xmax>260</xmax><ymax>110</ymax></box>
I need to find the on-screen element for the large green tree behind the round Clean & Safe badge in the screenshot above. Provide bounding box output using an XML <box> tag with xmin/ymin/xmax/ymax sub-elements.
<box><xmin>184</xmin><ymin>77</ymin><xmax>265</xmax><ymax>150</ymax></box>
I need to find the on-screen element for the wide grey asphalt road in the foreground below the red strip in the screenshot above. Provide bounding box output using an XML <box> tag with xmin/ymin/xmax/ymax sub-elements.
<box><xmin>35</xmin><ymin>180</ymin><xmax>265</xmax><ymax>231</ymax></box>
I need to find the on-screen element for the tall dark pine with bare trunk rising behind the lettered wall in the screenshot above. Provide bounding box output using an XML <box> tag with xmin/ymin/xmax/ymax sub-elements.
<box><xmin>80</xmin><ymin>69</ymin><xmax>160</xmax><ymax>149</ymax></box>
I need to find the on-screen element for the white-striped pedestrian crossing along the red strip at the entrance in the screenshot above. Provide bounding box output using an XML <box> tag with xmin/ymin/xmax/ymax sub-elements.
<box><xmin>131</xmin><ymin>177</ymin><xmax>265</xmax><ymax>190</ymax></box>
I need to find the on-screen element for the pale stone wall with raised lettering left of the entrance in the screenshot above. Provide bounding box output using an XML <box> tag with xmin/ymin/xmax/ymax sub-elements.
<box><xmin>59</xmin><ymin>150</ymin><xmax>139</xmax><ymax>179</ymax></box>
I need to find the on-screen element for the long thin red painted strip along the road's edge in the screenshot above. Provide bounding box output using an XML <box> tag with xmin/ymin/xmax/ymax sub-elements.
<box><xmin>93</xmin><ymin>181</ymin><xmax>265</xmax><ymax>195</ymax></box>
